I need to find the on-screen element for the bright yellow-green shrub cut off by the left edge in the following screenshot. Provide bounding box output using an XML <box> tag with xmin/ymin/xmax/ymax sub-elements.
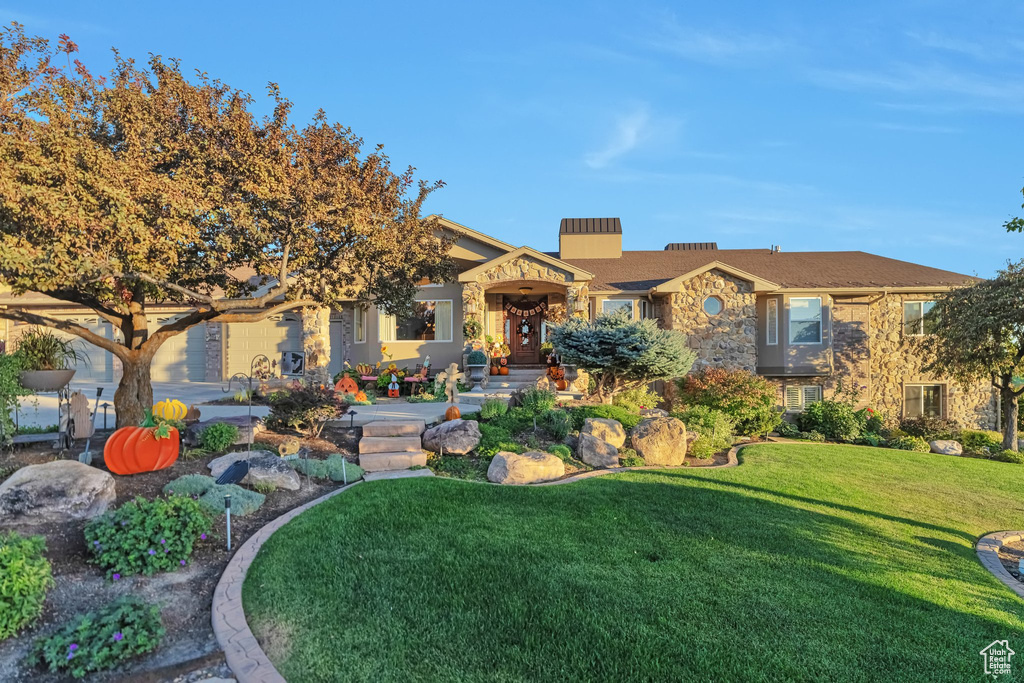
<box><xmin>0</xmin><ymin>531</ymin><xmax>53</xmax><ymax>640</ymax></box>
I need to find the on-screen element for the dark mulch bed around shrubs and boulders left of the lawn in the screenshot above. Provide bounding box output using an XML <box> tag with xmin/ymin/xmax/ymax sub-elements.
<box><xmin>0</xmin><ymin>428</ymin><xmax>361</xmax><ymax>683</ymax></box>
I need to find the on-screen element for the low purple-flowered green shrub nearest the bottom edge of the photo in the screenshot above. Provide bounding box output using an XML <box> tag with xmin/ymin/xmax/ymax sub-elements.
<box><xmin>30</xmin><ymin>597</ymin><xmax>165</xmax><ymax>678</ymax></box>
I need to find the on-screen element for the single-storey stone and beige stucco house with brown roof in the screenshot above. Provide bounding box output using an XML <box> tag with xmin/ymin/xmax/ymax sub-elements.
<box><xmin>0</xmin><ymin>218</ymin><xmax>997</xmax><ymax>428</ymax></box>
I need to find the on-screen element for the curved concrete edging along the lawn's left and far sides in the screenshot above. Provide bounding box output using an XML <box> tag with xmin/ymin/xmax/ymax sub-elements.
<box><xmin>211</xmin><ymin>443</ymin><xmax>756</xmax><ymax>683</ymax></box>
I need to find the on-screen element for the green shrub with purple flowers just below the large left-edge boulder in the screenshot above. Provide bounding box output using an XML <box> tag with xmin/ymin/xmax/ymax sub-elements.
<box><xmin>85</xmin><ymin>496</ymin><xmax>211</xmax><ymax>577</ymax></box>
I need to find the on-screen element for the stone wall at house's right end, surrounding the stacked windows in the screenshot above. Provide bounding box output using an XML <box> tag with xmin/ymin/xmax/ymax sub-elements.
<box><xmin>868</xmin><ymin>294</ymin><xmax>997</xmax><ymax>429</ymax></box>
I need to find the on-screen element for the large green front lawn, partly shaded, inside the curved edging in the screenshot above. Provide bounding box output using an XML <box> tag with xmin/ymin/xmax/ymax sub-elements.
<box><xmin>244</xmin><ymin>445</ymin><xmax>1024</xmax><ymax>683</ymax></box>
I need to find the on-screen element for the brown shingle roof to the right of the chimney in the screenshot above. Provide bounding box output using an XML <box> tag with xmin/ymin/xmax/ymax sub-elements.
<box><xmin>566</xmin><ymin>249</ymin><xmax>977</xmax><ymax>291</ymax></box>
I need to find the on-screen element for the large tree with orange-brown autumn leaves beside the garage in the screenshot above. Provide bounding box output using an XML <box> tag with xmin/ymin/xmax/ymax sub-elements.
<box><xmin>0</xmin><ymin>24</ymin><xmax>453</xmax><ymax>426</ymax></box>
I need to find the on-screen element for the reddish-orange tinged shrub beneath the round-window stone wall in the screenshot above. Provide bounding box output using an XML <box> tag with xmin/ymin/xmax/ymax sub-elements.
<box><xmin>679</xmin><ymin>368</ymin><xmax>782</xmax><ymax>436</ymax></box>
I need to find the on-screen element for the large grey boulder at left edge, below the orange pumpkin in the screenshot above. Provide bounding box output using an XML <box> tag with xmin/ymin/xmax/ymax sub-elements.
<box><xmin>0</xmin><ymin>460</ymin><xmax>117</xmax><ymax>524</ymax></box>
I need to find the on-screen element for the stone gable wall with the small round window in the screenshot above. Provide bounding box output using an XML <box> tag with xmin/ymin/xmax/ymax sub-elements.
<box><xmin>656</xmin><ymin>270</ymin><xmax>758</xmax><ymax>372</ymax></box>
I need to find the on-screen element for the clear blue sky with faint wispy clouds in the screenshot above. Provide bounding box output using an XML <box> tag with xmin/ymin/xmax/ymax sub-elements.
<box><xmin>8</xmin><ymin>0</ymin><xmax>1024</xmax><ymax>275</ymax></box>
